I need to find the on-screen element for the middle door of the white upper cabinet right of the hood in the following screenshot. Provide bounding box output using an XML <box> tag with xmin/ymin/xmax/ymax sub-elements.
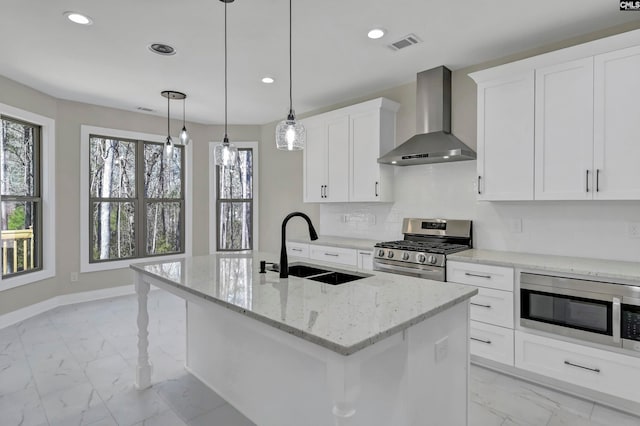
<box><xmin>535</xmin><ymin>58</ymin><xmax>594</xmax><ymax>200</ymax></box>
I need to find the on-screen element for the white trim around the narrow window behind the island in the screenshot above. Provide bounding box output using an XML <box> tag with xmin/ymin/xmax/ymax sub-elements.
<box><xmin>209</xmin><ymin>142</ymin><xmax>260</xmax><ymax>254</ymax></box>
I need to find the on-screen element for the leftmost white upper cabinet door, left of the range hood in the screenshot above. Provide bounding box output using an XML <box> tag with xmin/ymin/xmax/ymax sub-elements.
<box><xmin>303</xmin><ymin>120</ymin><xmax>328</xmax><ymax>203</ymax></box>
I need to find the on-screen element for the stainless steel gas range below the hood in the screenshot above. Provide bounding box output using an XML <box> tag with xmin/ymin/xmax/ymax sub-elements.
<box><xmin>373</xmin><ymin>219</ymin><xmax>472</xmax><ymax>281</ymax></box>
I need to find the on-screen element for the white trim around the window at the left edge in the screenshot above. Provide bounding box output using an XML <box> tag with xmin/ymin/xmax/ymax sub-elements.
<box><xmin>0</xmin><ymin>103</ymin><xmax>56</xmax><ymax>291</ymax></box>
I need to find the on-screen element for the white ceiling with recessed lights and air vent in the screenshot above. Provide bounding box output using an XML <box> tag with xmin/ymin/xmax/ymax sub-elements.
<box><xmin>0</xmin><ymin>0</ymin><xmax>638</xmax><ymax>124</ymax></box>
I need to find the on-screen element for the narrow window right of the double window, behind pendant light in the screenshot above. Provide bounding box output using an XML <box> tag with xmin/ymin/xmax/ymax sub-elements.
<box><xmin>216</xmin><ymin>148</ymin><xmax>254</xmax><ymax>251</ymax></box>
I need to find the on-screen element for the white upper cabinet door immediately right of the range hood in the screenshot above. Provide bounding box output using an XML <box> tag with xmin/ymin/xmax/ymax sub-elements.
<box><xmin>477</xmin><ymin>71</ymin><xmax>534</xmax><ymax>200</ymax></box>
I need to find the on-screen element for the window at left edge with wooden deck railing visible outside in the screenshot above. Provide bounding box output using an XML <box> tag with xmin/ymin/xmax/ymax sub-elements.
<box><xmin>0</xmin><ymin>115</ymin><xmax>42</xmax><ymax>278</ymax></box>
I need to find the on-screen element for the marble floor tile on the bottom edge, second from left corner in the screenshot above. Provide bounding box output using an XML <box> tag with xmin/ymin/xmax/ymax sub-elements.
<box><xmin>42</xmin><ymin>383</ymin><xmax>113</xmax><ymax>426</ymax></box>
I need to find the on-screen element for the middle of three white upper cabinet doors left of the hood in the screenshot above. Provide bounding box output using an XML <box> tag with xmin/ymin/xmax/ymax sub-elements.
<box><xmin>323</xmin><ymin>115</ymin><xmax>349</xmax><ymax>202</ymax></box>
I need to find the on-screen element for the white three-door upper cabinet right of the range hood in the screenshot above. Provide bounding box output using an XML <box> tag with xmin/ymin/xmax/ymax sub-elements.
<box><xmin>470</xmin><ymin>30</ymin><xmax>640</xmax><ymax>201</ymax></box>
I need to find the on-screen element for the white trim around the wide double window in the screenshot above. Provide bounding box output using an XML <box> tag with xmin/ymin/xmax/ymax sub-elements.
<box><xmin>80</xmin><ymin>125</ymin><xmax>193</xmax><ymax>272</ymax></box>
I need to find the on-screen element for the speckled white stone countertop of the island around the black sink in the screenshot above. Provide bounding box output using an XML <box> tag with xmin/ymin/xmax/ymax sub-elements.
<box><xmin>131</xmin><ymin>252</ymin><xmax>477</xmax><ymax>355</ymax></box>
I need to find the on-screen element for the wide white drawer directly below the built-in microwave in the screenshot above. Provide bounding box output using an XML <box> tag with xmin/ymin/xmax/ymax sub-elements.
<box><xmin>515</xmin><ymin>331</ymin><xmax>640</xmax><ymax>402</ymax></box>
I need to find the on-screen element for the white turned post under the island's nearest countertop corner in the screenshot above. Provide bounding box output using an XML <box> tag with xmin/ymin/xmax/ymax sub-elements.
<box><xmin>327</xmin><ymin>352</ymin><xmax>360</xmax><ymax>426</ymax></box>
